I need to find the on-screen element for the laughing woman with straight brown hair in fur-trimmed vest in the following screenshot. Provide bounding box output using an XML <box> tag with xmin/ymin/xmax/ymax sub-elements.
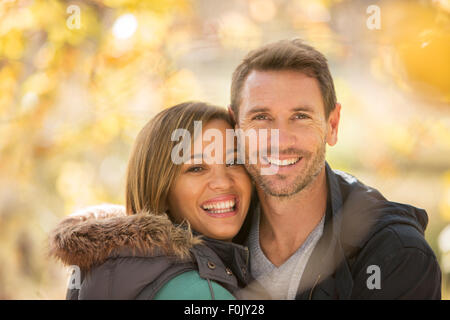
<box><xmin>50</xmin><ymin>103</ymin><xmax>259</xmax><ymax>299</ymax></box>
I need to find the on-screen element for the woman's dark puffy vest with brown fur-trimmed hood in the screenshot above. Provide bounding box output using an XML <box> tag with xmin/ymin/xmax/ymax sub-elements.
<box><xmin>50</xmin><ymin>214</ymin><xmax>268</xmax><ymax>300</ymax></box>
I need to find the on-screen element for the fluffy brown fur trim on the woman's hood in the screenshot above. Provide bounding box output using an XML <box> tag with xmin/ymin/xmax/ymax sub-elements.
<box><xmin>49</xmin><ymin>213</ymin><xmax>201</xmax><ymax>270</ymax></box>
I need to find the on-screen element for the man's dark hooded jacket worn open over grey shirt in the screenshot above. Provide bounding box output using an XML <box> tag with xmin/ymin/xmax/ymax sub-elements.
<box><xmin>235</xmin><ymin>164</ymin><xmax>441</xmax><ymax>299</ymax></box>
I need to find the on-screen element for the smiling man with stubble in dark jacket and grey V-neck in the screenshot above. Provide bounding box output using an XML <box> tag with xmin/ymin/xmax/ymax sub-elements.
<box><xmin>230</xmin><ymin>40</ymin><xmax>441</xmax><ymax>299</ymax></box>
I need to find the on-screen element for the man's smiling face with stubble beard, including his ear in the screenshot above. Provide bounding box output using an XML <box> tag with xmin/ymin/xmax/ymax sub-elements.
<box><xmin>237</xmin><ymin>70</ymin><xmax>340</xmax><ymax>197</ymax></box>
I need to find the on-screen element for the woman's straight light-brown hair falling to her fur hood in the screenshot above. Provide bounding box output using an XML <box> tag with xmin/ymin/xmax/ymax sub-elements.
<box><xmin>125</xmin><ymin>102</ymin><xmax>233</xmax><ymax>218</ymax></box>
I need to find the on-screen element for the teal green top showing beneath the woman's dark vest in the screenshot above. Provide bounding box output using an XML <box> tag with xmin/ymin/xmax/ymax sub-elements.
<box><xmin>154</xmin><ymin>270</ymin><xmax>236</xmax><ymax>300</ymax></box>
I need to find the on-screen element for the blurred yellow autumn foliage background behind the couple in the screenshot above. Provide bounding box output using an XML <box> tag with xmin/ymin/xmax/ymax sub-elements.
<box><xmin>0</xmin><ymin>0</ymin><xmax>450</xmax><ymax>299</ymax></box>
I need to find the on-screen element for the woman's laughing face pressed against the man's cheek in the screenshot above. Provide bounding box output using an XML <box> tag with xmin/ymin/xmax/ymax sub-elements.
<box><xmin>168</xmin><ymin>120</ymin><xmax>252</xmax><ymax>241</ymax></box>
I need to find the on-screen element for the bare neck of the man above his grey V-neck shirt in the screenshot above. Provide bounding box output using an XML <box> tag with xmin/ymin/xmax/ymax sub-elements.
<box><xmin>258</xmin><ymin>167</ymin><xmax>327</xmax><ymax>266</ymax></box>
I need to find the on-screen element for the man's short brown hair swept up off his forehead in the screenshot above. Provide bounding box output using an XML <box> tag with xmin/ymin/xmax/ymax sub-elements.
<box><xmin>231</xmin><ymin>39</ymin><xmax>336</xmax><ymax>119</ymax></box>
